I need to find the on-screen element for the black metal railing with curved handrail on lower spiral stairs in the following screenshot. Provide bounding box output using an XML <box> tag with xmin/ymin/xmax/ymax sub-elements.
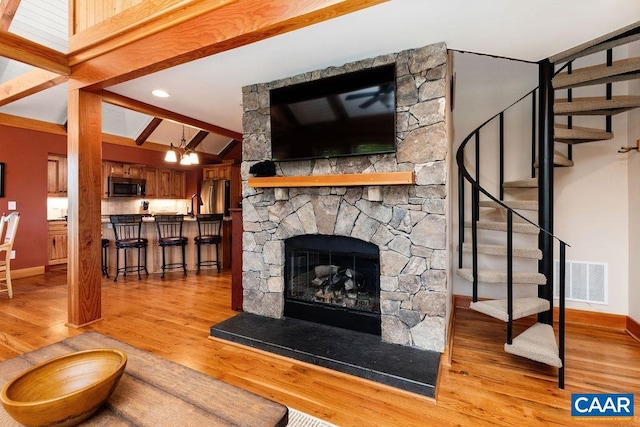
<box><xmin>456</xmin><ymin>88</ymin><xmax>570</xmax><ymax>388</ymax></box>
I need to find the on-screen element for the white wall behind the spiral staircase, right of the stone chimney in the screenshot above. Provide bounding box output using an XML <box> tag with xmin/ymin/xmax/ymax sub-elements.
<box><xmin>452</xmin><ymin>48</ymin><xmax>640</xmax><ymax>319</ymax></box>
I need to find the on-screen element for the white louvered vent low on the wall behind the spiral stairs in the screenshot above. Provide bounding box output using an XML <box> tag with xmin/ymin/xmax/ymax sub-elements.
<box><xmin>553</xmin><ymin>260</ymin><xmax>608</xmax><ymax>304</ymax></box>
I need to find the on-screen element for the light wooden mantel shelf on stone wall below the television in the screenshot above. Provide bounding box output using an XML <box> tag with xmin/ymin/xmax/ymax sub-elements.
<box><xmin>249</xmin><ymin>171</ymin><xmax>416</xmax><ymax>188</ymax></box>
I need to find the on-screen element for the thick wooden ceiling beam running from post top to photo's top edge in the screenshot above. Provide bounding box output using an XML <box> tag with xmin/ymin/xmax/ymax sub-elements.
<box><xmin>69</xmin><ymin>0</ymin><xmax>387</xmax><ymax>90</ymax></box>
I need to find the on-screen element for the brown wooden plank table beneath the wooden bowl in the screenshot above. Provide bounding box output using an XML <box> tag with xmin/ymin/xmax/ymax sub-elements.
<box><xmin>0</xmin><ymin>332</ymin><xmax>288</xmax><ymax>427</ymax></box>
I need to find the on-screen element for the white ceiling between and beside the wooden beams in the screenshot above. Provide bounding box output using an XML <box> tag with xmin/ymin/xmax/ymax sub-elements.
<box><xmin>0</xmin><ymin>0</ymin><xmax>640</xmax><ymax>154</ymax></box>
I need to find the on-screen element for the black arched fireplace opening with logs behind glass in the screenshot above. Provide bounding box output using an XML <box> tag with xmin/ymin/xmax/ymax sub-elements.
<box><xmin>284</xmin><ymin>234</ymin><xmax>381</xmax><ymax>335</ymax></box>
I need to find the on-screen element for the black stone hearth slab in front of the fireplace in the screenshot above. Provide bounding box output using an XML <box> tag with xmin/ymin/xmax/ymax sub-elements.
<box><xmin>210</xmin><ymin>313</ymin><xmax>440</xmax><ymax>397</ymax></box>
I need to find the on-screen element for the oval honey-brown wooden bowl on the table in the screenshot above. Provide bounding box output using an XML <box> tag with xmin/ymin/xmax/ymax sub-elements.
<box><xmin>0</xmin><ymin>348</ymin><xmax>127</xmax><ymax>427</ymax></box>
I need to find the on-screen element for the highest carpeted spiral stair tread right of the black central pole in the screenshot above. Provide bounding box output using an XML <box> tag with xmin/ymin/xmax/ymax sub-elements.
<box><xmin>551</xmin><ymin>58</ymin><xmax>640</xmax><ymax>89</ymax></box>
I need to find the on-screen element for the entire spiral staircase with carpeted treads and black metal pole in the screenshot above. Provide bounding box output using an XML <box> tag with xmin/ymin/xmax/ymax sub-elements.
<box><xmin>456</xmin><ymin>23</ymin><xmax>640</xmax><ymax>388</ymax></box>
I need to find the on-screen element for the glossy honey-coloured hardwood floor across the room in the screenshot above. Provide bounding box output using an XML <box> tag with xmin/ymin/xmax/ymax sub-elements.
<box><xmin>0</xmin><ymin>270</ymin><xmax>640</xmax><ymax>426</ymax></box>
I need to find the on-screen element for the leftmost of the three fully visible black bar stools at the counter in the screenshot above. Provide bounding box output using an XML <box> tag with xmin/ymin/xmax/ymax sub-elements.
<box><xmin>109</xmin><ymin>214</ymin><xmax>149</xmax><ymax>282</ymax></box>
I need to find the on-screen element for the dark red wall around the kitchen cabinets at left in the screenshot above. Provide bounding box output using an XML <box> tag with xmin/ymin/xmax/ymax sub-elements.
<box><xmin>0</xmin><ymin>125</ymin><xmax>202</xmax><ymax>270</ymax></box>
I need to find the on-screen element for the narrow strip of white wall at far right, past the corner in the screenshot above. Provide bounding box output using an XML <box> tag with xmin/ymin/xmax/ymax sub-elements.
<box><xmin>628</xmin><ymin>42</ymin><xmax>640</xmax><ymax>322</ymax></box>
